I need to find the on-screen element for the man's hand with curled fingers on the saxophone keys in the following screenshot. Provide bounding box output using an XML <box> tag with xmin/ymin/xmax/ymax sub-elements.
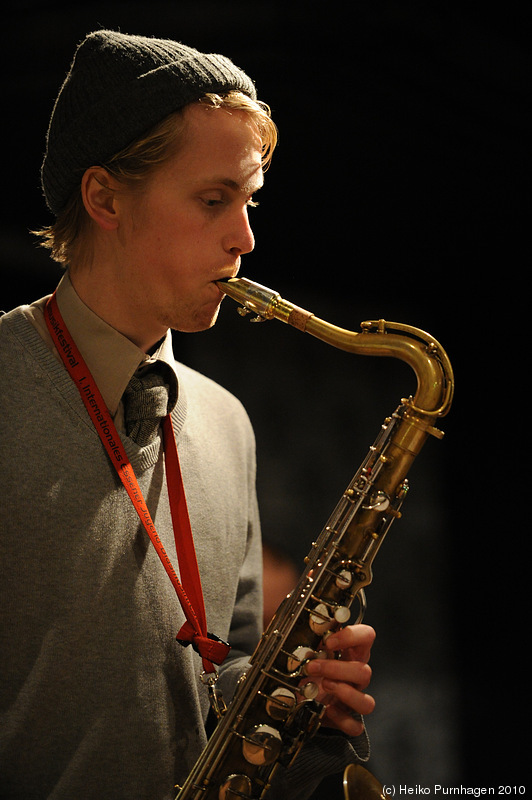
<box><xmin>306</xmin><ymin>625</ymin><xmax>375</xmax><ymax>736</ymax></box>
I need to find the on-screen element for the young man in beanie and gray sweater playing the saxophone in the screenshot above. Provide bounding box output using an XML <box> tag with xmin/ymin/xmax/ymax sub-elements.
<box><xmin>0</xmin><ymin>30</ymin><xmax>374</xmax><ymax>800</ymax></box>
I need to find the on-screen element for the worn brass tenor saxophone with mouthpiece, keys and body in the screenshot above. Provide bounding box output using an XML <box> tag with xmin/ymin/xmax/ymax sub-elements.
<box><xmin>176</xmin><ymin>278</ymin><xmax>454</xmax><ymax>800</ymax></box>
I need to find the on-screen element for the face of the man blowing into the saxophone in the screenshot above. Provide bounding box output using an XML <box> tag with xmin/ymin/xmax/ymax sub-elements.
<box><xmin>116</xmin><ymin>105</ymin><xmax>263</xmax><ymax>335</ymax></box>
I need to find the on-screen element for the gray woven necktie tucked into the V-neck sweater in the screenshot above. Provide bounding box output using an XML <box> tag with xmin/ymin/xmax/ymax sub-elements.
<box><xmin>123</xmin><ymin>370</ymin><xmax>168</xmax><ymax>447</ymax></box>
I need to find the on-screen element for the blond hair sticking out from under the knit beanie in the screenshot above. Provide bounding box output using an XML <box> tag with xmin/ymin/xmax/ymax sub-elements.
<box><xmin>33</xmin><ymin>90</ymin><xmax>277</xmax><ymax>268</ymax></box>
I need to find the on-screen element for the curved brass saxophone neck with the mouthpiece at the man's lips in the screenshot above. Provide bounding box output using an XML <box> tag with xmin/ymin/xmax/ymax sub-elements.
<box><xmin>218</xmin><ymin>278</ymin><xmax>454</xmax><ymax>418</ymax></box>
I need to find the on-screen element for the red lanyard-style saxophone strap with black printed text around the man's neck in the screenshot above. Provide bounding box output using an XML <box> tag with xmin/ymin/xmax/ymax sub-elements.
<box><xmin>45</xmin><ymin>293</ymin><xmax>230</xmax><ymax>673</ymax></box>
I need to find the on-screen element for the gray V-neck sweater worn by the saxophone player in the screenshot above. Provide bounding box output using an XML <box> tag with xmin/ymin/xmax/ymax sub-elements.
<box><xmin>0</xmin><ymin>309</ymin><xmax>261</xmax><ymax>800</ymax></box>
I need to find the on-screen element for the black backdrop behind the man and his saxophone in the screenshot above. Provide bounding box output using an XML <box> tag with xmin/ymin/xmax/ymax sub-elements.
<box><xmin>0</xmin><ymin>0</ymin><xmax>531</xmax><ymax>790</ymax></box>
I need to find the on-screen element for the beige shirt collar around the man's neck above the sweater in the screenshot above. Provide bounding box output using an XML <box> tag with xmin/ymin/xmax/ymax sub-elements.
<box><xmin>25</xmin><ymin>272</ymin><xmax>177</xmax><ymax>431</ymax></box>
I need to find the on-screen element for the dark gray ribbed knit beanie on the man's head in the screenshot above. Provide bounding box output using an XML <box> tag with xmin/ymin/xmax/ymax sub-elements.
<box><xmin>41</xmin><ymin>30</ymin><xmax>256</xmax><ymax>215</ymax></box>
